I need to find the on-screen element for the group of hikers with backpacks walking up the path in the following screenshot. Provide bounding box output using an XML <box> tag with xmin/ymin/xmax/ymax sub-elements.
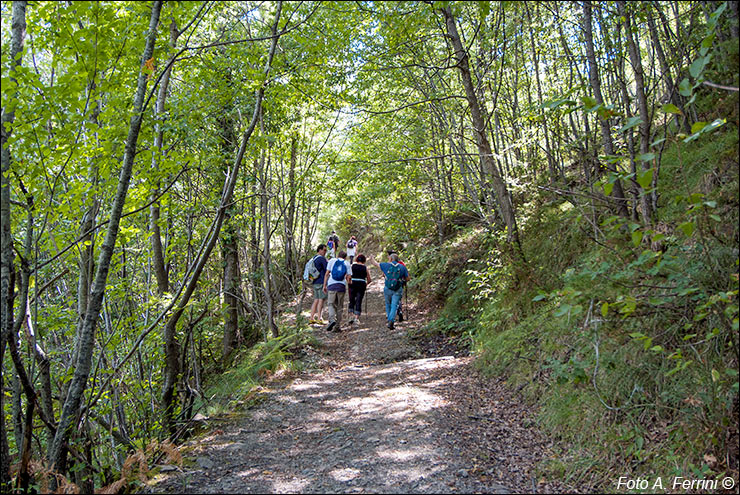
<box><xmin>303</xmin><ymin>232</ymin><xmax>409</xmax><ymax>332</ymax></box>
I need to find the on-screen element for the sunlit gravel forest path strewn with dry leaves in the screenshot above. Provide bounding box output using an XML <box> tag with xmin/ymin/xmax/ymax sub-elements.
<box><xmin>149</xmin><ymin>270</ymin><xmax>572</xmax><ymax>493</ymax></box>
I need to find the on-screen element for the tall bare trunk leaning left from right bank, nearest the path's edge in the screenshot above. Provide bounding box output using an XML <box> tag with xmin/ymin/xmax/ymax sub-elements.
<box><xmin>442</xmin><ymin>7</ymin><xmax>521</xmax><ymax>254</ymax></box>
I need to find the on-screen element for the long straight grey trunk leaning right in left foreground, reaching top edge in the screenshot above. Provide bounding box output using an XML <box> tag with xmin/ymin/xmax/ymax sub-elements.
<box><xmin>49</xmin><ymin>0</ymin><xmax>162</xmax><ymax>472</ymax></box>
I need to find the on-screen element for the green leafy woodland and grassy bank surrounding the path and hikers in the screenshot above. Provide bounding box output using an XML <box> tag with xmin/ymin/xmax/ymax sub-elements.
<box><xmin>0</xmin><ymin>1</ymin><xmax>740</xmax><ymax>492</ymax></box>
